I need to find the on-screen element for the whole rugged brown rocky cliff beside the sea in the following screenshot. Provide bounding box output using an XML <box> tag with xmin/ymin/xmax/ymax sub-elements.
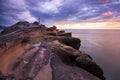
<box><xmin>0</xmin><ymin>22</ymin><xmax>105</xmax><ymax>80</ymax></box>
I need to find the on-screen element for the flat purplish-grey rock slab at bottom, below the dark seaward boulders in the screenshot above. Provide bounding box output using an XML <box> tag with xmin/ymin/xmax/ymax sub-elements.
<box><xmin>51</xmin><ymin>55</ymin><xmax>100</xmax><ymax>80</ymax></box>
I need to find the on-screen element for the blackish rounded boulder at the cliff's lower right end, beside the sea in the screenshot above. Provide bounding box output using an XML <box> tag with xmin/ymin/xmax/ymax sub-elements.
<box><xmin>75</xmin><ymin>53</ymin><xmax>105</xmax><ymax>80</ymax></box>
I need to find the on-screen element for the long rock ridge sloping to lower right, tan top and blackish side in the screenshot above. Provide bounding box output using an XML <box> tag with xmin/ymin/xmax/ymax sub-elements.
<box><xmin>49</xmin><ymin>41</ymin><xmax>105</xmax><ymax>80</ymax></box>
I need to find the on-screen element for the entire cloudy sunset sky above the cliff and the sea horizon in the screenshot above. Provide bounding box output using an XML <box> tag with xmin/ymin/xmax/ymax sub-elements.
<box><xmin>0</xmin><ymin>0</ymin><xmax>120</xmax><ymax>29</ymax></box>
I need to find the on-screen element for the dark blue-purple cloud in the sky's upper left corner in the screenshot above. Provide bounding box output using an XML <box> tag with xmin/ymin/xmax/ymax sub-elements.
<box><xmin>0</xmin><ymin>0</ymin><xmax>25</xmax><ymax>25</ymax></box>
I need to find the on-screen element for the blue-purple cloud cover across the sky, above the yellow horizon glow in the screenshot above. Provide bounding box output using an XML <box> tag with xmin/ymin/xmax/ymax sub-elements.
<box><xmin>0</xmin><ymin>0</ymin><xmax>120</xmax><ymax>24</ymax></box>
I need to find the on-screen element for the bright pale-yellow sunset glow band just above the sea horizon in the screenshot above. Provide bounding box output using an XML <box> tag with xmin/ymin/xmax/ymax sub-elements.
<box><xmin>56</xmin><ymin>19</ymin><xmax>120</xmax><ymax>29</ymax></box>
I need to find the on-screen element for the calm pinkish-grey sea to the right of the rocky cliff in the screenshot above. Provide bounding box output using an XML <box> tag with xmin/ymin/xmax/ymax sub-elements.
<box><xmin>63</xmin><ymin>29</ymin><xmax>120</xmax><ymax>80</ymax></box>
